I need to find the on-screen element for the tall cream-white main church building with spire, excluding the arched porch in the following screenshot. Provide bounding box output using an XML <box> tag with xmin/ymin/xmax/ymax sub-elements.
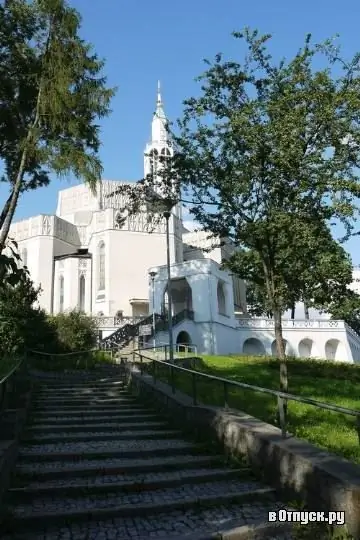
<box><xmin>9</xmin><ymin>88</ymin><xmax>246</xmax><ymax>324</ymax></box>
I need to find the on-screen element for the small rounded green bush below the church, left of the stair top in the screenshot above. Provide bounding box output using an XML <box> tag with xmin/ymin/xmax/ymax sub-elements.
<box><xmin>49</xmin><ymin>310</ymin><xmax>97</xmax><ymax>352</ymax></box>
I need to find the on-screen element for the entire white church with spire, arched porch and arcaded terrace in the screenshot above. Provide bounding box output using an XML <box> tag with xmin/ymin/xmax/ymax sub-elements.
<box><xmin>9</xmin><ymin>88</ymin><xmax>360</xmax><ymax>362</ymax></box>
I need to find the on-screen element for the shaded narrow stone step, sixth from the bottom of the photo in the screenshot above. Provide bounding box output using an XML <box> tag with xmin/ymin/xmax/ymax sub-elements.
<box><xmin>22</xmin><ymin>429</ymin><xmax>182</xmax><ymax>444</ymax></box>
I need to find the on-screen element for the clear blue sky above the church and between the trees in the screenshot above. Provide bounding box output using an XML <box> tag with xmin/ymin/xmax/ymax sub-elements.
<box><xmin>0</xmin><ymin>0</ymin><xmax>360</xmax><ymax>264</ymax></box>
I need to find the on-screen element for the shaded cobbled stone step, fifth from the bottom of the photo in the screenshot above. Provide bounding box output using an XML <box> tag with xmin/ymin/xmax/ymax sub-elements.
<box><xmin>19</xmin><ymin>439</ymin><xmax>198</xmax><ymax>462</ymax></box>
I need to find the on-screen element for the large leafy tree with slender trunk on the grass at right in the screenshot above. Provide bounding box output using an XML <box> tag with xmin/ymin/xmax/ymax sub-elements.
<box><xmin>169</xmin><ymin>29</ymin><xmax>360</xmax><ymax>390</ymax></box>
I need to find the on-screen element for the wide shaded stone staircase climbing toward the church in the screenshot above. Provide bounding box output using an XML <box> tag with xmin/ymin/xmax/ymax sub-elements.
<box><xmin>0</xmin><ymin>370</ymin><xmax>293</xmax><ymax>540</ymax></box>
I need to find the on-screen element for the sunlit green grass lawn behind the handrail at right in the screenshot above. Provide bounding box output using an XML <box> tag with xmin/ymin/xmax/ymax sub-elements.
<box><xmin>151</xmin><ymin>356</ymin><xmax>360</xmax><ymax>463</ymax></box>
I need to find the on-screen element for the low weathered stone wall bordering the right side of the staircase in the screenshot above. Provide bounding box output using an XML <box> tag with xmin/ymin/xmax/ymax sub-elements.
<box><xmin>127</xmin><ymin>368</ymin><xmax>360</xmax><ymax>538</ymax></box>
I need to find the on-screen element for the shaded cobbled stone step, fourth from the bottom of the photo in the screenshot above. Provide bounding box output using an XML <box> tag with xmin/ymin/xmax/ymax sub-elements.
<box><xmin>15</xmin><ymin>453</ymin><xmax>224</xmax><ymax>481</ymax></box>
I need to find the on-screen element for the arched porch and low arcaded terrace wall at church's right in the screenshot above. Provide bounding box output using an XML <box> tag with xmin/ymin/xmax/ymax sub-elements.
<box><xmin>149</xmin><ymin>259</ymin><xmax>360</xmax><ymax>363</ymax></box>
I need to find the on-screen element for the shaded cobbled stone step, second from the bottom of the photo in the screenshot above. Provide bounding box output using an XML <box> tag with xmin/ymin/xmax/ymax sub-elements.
<box><xmin>2</xmin><ymin>480</ymin><xmax>275</xmax><ymax>530</ymax></box>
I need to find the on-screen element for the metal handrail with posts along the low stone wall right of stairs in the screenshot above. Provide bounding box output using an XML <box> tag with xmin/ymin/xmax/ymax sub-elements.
<box><xmin>133</xmin><ymin>350</ymin><xmax>360</xmax><ymax>444</ymax></box>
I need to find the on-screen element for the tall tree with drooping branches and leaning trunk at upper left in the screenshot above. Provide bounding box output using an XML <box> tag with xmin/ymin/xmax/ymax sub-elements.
<box><xmin>0</xmin><ymin>0</ymin><xmax>114</xmax><ymax>253</ymax></box>
